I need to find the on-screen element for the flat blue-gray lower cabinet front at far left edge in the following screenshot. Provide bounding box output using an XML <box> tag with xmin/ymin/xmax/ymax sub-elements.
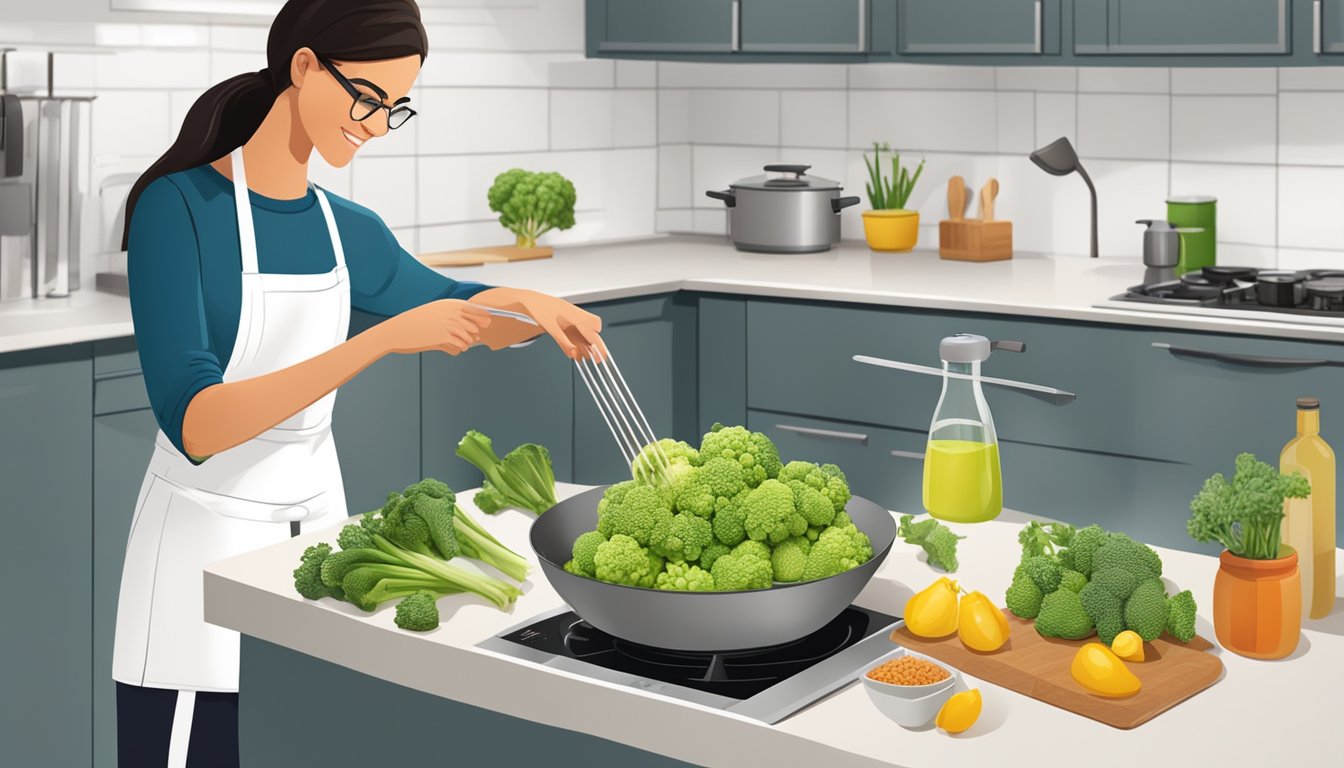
<box><xmin>0</xmin><ymin>344</ymin><xmax>94</xmax><ymax>765</ymax></box>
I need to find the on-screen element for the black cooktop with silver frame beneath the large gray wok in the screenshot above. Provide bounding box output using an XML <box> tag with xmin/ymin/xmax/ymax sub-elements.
<box><xmin>478</xmin><ymin>605</ymin><xmax>899</xmax><ymax>724</ymax></box>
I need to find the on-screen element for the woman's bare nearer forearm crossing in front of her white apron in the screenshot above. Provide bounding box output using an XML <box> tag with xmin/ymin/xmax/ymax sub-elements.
<box><xmin>181</xmin><ymin>325</ymin><xmax>387</xmax><ymax>459</ymax></box>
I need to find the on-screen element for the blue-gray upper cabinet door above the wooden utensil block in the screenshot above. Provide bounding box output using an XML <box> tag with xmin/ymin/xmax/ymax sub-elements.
<box><xmin>896</xmin><ymin>0</ymin><xmax>1059</xmax><ymax>55</ymax></box>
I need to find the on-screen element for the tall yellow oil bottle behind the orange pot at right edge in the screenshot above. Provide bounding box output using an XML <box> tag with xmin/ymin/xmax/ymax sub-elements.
<box><xmin>1279</xmin><ymin>397</ymin><xmax>1335</xmax><ymax>619</ymax></box>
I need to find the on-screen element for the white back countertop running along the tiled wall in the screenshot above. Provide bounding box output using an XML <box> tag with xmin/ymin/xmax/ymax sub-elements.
<box><xmin>0</xmin><ymin>235</ymin><xmax>1344</xmax><ymax>352</ymax></box>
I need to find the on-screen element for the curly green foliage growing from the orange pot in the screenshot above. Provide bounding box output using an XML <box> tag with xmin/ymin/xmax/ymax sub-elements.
<box><xmin>1185</xmin><ymin>453</ymin><xmax>1312</xmax><ymax>560</ymax></box>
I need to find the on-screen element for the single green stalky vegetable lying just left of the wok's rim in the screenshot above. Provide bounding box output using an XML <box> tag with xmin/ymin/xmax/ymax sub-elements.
<box><xmin>457</xmin><ymin>429</ymin><xmax>555</xmax><ymax>514</ymax></box>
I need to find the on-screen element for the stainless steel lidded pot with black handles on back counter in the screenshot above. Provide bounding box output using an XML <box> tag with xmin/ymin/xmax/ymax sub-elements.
<box><xmin>706</xmin><ymin>164</ymin><xmax>860</xmax><ymax>253</ymax></box>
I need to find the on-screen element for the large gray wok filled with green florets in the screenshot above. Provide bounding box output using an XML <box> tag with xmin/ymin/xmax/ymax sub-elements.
<box><xmin>531</xmin><ymin>487</ymin><xmax>896</xmax><ymax>651</ymax></box>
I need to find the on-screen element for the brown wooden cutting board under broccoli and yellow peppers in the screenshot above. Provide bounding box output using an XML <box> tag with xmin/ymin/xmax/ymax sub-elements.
<box><xmin>891</xmin><ymin>611</ymin><xmax>1223</xmax><ymax>729</ymax></box>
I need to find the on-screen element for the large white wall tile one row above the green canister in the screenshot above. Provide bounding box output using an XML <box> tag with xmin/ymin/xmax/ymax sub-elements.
<box><xmin>1171</xmin><ymin>95</ymin><xmax>1278</xmax><ymax>164</ymax></box>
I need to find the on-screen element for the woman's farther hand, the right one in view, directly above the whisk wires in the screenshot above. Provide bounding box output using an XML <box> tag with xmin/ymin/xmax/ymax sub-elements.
<box><xmin>470</xmin><ymin>288</ymin><xmax>606</xmax><ymax>360</ymax></box>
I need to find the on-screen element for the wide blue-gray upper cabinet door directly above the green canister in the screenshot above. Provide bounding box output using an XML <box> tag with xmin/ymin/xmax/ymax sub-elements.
<box><xmin>1074</xmin><ymin>0</ymin><xmax>1292</xmax><ymax>55</ymax></box>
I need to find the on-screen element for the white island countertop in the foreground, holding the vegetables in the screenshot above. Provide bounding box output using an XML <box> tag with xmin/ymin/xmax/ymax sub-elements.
<box><xmin>206</xmin><ymin>484</ymin><xmax>1344</xmax><ymax>768</ymax></box>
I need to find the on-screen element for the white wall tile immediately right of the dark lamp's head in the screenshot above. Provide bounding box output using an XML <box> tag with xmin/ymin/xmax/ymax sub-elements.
<box><xmin>1075</xmin><ymin>96</ymin><xmax>1171</xmax><ymax>160</ymax></box>
